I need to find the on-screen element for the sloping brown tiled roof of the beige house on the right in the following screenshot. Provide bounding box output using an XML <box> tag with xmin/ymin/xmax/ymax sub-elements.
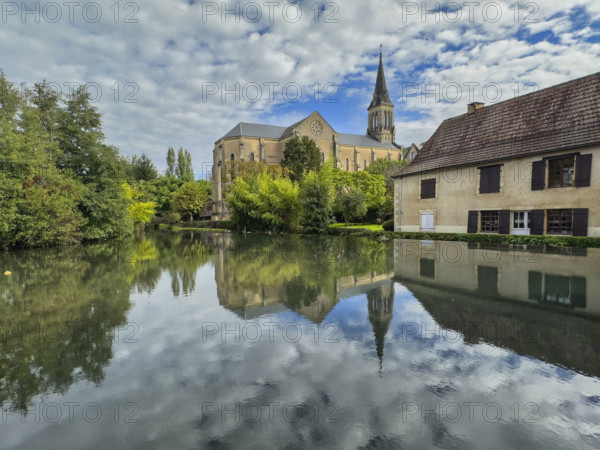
<box><xmin>395</xmin><ymin>73</ymin><xmax>600</xmax><ymax>177</ymax></box>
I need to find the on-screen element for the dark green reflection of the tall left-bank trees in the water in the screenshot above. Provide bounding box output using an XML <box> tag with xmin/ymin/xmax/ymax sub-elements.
<box><xmin>0</xmin><ymin>244</ymin><xmax>131</xmax><ymax>410</ymax></box>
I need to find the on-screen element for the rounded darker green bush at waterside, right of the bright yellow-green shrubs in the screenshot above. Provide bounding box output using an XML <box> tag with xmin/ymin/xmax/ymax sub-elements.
<box><xmin>299</xmin><ymin>171</ymin><xmax>334</xmax><ymax>231</ymax></box>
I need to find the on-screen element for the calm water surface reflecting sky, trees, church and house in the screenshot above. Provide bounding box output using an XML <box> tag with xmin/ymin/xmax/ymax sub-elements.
<box><xmin>0</xmin><ymin>231</ymin><xmax>600</xmax><ymax>450</ymax></box>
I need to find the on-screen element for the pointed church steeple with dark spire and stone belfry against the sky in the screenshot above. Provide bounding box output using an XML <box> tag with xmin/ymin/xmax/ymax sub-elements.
<box><xmin>367</xmin><ymin>46</ymin><xmax>396</xmax><ymax>142</ymax></box>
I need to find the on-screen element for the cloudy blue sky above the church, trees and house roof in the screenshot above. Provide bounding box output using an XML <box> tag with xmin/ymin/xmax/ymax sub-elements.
<box><xmin>0</xmin><ymin>0</ymin><xmax>600</xmax><ymax>178</ymax></box>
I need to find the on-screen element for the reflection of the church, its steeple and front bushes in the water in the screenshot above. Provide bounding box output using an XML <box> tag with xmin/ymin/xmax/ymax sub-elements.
<box><xmin>210</xmin><ymin>234</ymin><xmax>394</xmax><ymax>365</ymax></box>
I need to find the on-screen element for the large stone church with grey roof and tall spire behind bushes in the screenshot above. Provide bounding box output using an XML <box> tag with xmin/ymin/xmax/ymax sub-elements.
<box><xmin>212</xmin><ymin>52</ymin><xmax>408</xmax><ymax>220</ymax></box>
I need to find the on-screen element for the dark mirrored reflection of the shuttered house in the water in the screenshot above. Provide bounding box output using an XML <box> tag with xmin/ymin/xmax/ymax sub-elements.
<box><xmin>394</xmin><ymin>241</ymin><xmax>600</xmax><ymax>376</ymax></box>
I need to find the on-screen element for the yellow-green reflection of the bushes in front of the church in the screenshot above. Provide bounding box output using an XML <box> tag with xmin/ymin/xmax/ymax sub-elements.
<box><xmin>215</xmin><ymin>235</ymin><xmax>393</xmax><ymax>319</ymax></box>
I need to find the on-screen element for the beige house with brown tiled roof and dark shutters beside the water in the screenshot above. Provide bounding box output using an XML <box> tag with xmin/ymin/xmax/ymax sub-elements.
<box><xmin>394</xmin><ymin>73</ymin><xmax>600</xmax><ymax>236</ymax></box>
